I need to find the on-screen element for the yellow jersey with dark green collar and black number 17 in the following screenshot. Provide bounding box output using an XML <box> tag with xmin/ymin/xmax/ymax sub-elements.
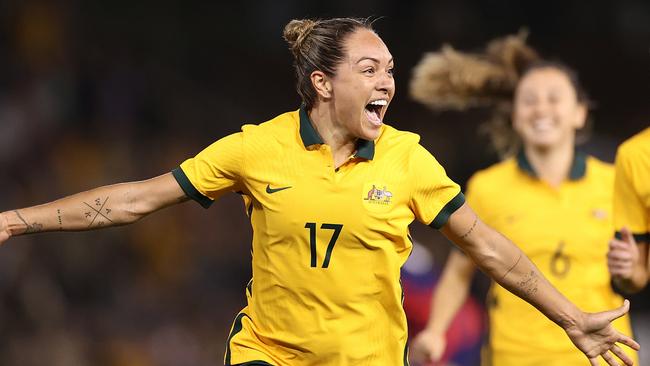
<box><xmin>168</xmin><ymin>109</ymin><xmax>464</xmax><ymax>366</ymax></box>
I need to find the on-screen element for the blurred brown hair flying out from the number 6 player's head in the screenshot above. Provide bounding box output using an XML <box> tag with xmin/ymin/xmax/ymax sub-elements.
<box><xmin>410</xmin><ymin>31</ymin><xmax>590</xmax><ymax>158</ymax></box>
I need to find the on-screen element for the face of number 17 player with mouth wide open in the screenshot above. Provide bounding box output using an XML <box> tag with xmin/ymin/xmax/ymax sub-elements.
<box><xmin>331</xmin><ymin>28</ymin><xmax>395</xmax><ymax>140</ymax></box>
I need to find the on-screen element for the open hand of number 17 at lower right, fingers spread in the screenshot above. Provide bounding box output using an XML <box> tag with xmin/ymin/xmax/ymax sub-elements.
<box><xmin>565</xmin><ymin>300</ymin><xmax>640</xmax><ymax>366</ymax></box>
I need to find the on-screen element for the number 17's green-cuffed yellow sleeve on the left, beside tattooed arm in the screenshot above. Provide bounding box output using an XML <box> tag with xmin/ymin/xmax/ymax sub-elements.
<box><xmin>172</xmin><ymin>132</ymin><xmax>243</xmax><ymax>208</ymax></box>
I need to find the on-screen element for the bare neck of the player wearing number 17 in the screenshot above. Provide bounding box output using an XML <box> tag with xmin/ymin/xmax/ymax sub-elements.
<box><xmin>308</xmin><ymin>106</ymin><xmax>357</xmax><ymax>167</ymax></box>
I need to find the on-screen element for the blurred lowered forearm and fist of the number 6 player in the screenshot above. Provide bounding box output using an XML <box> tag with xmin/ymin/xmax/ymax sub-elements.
<box><xmin>411</xmin><ymin>250</ymin><xmax>476</xmax><ymax>364</ymax></box>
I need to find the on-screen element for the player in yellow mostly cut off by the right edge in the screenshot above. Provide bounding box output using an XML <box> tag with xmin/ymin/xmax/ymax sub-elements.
<box><xmin>607</xmin><ymin>127</ymin><xmax>650</xmax><ymax>293</ymax></box>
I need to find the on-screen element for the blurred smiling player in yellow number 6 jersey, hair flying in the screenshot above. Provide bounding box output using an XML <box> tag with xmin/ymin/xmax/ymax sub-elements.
<box><xmin>413</xmin><ymin>33</ymin><xmax>636</xmax><ymax>366</ymax></box>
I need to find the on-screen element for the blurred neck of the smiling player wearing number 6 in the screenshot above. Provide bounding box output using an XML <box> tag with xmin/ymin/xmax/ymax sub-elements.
<box><xmin>524</xmin><ymin>141</ymin><xmax>575</xmax><ymax>187</ymax></box>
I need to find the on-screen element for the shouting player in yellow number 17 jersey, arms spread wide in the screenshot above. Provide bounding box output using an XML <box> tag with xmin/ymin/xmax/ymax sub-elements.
<box><xmin>0</xmin><ymin>18</ymin><xmax>638</xmax><ymax>365</ymax></box>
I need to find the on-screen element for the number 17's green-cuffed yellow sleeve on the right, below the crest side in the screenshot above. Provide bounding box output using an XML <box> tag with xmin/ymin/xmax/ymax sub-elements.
<box><xmin>409</xmin><ymin>144</ymin><xmax>465</xmax><ymax>229</ymax></box>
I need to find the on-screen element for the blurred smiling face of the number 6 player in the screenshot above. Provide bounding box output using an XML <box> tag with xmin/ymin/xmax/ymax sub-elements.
<box><xmin>512</xmin><ymin>67</ymin><xmax>587</xmax><ymax>149</ymax></box>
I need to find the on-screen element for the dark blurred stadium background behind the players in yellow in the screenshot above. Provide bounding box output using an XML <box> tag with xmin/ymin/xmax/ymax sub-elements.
<box><xmin>0</xmin><ymin>0</ymin><xmax>650</xmax><ymax>366</ymax></box>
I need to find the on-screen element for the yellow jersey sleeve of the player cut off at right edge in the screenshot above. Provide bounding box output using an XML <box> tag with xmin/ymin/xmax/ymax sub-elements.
<box><xmin>614</xmin><ymin>144</ymin><xmax>650</xmax><ymax>242</ymax></box>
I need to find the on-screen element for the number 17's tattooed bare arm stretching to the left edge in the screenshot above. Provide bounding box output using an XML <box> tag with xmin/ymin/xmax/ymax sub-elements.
<box><xmin>0</xmin><ymin>173</ymin><xmax>188</xmax><ymax>243</ymax></box>
